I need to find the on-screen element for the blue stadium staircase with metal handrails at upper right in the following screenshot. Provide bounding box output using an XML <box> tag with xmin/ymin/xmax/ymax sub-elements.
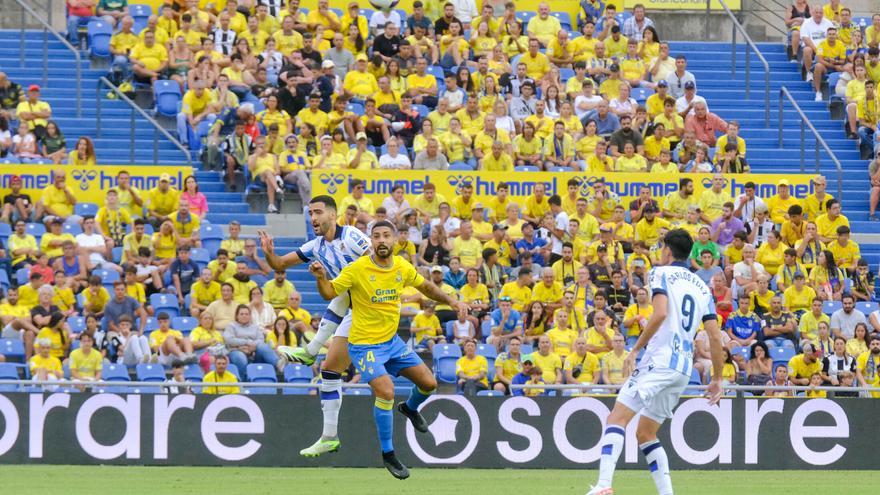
<box><xmin>670</xmin><ymin>42</ymin><xmax>880</xmax><ymax>273</ymax></box>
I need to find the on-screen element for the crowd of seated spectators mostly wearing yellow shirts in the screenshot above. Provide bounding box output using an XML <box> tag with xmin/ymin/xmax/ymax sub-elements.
<box><xmin>0</xmin><ymin>0</ymin><xmax>880</xmax><ymax>393</ymax></box>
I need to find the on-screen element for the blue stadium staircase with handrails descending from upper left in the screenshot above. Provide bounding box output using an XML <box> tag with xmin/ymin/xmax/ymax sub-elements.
<box><xmin>0</xmin><ymin>30</ymin><xmax>326</xmax><ymax>312</ymax></box>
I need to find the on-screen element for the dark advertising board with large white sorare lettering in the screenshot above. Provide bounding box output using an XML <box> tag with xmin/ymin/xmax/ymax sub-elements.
<box><xmin>0</xmin><ymin>393</ymin><xmax>868</xmax><ymax>469</ymax></box>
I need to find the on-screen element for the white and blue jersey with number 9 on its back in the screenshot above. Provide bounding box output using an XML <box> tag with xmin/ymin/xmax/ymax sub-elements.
<box><xmin>639</xmin><ymin>264</ymin><xmax>717</xmax><ymax>376</ymax></box>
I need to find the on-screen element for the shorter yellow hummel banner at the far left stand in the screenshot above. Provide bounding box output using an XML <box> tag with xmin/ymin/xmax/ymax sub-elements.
<box><xmin>0</xmin><ymin>165</ymin><xmax>193</xmax><ymax>206</ymax></box>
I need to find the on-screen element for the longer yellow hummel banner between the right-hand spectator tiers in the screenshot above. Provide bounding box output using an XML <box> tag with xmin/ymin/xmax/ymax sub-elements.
<box><xmin>312</xmin><ymin>170</ymin><xmax>814</xmax><ymax>210</ymax></box>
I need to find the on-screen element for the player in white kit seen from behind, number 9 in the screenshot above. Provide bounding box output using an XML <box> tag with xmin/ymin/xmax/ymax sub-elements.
<box><xmin>587</xmin><ymin>229</ymin><xmax>724</xmax><ymax>495</ymax></box>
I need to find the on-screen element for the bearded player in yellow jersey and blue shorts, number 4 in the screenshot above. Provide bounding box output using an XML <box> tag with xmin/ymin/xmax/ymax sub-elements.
<box><xmin>309</xmin><ymin>220</ymin><xmax>466</xmax><ymax>479</ymax></box>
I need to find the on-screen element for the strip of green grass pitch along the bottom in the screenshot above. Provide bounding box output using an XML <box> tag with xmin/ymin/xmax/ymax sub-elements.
<box><xmin>0</xmin><ymin>465</ymin><xmax>880</xmax><ymax>495</ymax></box>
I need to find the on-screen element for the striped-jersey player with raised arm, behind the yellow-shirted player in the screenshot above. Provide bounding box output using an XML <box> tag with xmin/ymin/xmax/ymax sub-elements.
<box><xmin>259</xmin><ymin>196</ymin><xmax>370</xmax><ymax>457</ymax></box>
